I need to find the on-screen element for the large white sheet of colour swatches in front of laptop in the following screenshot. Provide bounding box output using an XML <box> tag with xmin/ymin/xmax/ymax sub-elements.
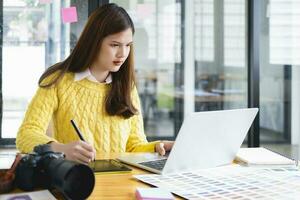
<box><xmin>135</xmin><ymin>165</ymin><xmax>300</xmax><ymax>200</ymax></box>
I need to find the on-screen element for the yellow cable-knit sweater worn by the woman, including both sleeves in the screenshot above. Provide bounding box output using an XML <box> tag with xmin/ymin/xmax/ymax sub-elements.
<box><xmin>16</xmin><ymin>73</ymin><xmax>157</xmax><ymax>153</ymax></box>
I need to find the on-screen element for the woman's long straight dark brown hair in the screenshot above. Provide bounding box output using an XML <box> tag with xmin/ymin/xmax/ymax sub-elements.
<box><xmin>39</xmin><ymin>3</ymin><xmax>137</xmax><ymax>118</ymax></box>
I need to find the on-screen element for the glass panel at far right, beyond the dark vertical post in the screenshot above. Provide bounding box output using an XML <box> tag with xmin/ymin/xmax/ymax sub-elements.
<box><xmin>260</xmin><ymin>0</ymin><xmax>300</xmax><ymax>158</ymax></box>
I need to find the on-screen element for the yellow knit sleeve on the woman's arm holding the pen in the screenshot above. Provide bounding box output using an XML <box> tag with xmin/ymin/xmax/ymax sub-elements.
<box><xmin>16</xmin><ymin>79</ymin><xmax>58</xmax><ymax>153</ymax></box>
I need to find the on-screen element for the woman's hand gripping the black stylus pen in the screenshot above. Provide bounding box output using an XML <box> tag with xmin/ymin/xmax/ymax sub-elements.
<box><xmin>50</xmin><ymin>140</ymin><xmax>96</xmax><ymax>164</ymax></box>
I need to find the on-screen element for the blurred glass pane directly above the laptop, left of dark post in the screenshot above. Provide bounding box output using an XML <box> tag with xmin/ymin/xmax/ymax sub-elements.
<box><xmin>193</xmin><ymin>0</ymin><xmax>248</xmax><ymax>114</ymax></box>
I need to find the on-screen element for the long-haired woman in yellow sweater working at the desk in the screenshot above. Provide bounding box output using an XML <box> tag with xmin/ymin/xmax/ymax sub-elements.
<box><xmin>16</xmin><ymin>4</ymin><xmax>173</xmax><ymax>163</ymax></box>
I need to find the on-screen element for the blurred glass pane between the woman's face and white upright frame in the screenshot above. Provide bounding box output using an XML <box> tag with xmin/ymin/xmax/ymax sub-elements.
<box><xmin>110</xmin><ymin>0</ymin><xmax>182</xmax><ymax>138</ymax></box>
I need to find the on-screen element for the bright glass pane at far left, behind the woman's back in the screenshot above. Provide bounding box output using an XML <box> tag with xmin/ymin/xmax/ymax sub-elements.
<box><xmin>1</xmin><ymin>0</ymin><xmax>88</xmax><ymax>138</ymax></box>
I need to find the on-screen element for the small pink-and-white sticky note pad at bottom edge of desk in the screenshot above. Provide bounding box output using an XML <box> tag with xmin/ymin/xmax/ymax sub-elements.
<box><xmin>135</xmin><ymin>188</ymin><xmax>174</xmax><ymax>200</ymax></box>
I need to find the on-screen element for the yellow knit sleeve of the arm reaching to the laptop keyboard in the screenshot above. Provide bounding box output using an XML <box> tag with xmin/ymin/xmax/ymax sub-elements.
<box><xmin>126</xmin><ymin>87</ymin><xmax>159</xmax><ymax>152</ymax></box>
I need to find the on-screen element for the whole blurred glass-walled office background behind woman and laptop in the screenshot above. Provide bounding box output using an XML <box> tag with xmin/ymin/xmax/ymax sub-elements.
<box><xmin>0</xmin><ymin>0</ymin><xmax>300</xmax><ymax>159</ymax></box>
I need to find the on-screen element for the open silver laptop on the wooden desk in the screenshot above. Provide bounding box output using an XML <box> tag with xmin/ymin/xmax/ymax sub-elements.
<box><xmin>118</xmin><ymin>108</ymin><xmax>258</xmax><ymax>174</ymax></box>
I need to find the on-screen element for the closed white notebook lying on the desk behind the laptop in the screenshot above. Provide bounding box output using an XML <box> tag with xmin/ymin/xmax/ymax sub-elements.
<box><xmin>235</xmin><ymin>147</ymin><xmax>295</xmax><ymax>166</ymax></box>
